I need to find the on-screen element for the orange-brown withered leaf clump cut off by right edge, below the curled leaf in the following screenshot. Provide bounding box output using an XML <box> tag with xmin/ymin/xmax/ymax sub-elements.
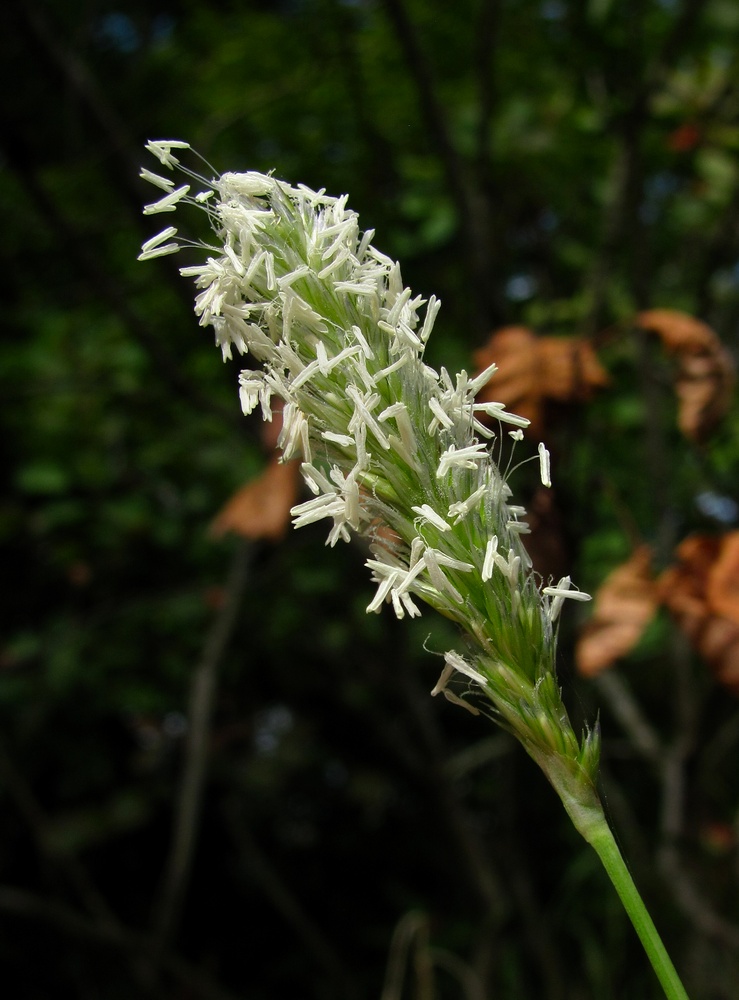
<box><xmin>659</xmin><ymin>531</ymin><xmax>739</xmax><ymax>694</ymax></box>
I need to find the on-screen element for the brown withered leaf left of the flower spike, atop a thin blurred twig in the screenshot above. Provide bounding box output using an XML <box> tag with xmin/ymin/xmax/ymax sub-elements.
<box><xmin>210</xmin><ymin>457</ymin><xmax>300</xmax><ymax>542</ymax></box>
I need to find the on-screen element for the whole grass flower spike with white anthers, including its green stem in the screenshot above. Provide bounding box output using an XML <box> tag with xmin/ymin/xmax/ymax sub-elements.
<box><xmin>139</xmin><ymin>141</ymin><xmax>685</xmax><ymax>1000</ymax></box>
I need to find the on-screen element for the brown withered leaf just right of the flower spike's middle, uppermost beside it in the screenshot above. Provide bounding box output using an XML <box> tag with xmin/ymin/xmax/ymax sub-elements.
<box><xmin>474</xmin><ymin>326</ymin><xmax>608</xmax><ymax>437</ymax></box>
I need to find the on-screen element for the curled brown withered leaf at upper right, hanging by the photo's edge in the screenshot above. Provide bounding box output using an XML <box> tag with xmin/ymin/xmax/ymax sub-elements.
<box><xmin>636</xmin><ymin>309</ymin><xmax>735</xmax><ymax>441</ymax></box>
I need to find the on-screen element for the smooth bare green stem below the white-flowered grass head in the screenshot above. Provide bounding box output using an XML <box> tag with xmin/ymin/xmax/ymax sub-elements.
<box><xmin>540</xmin><ymin>751</ymin><xmax>688</xmax><ymax>1000</ymax></box>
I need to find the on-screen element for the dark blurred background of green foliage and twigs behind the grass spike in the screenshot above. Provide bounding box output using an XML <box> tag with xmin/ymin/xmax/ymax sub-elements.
<box><xmin>0</xmin><ymin>0</ymin><xmax>739</xmax><ymax>1000</ymax></box>
